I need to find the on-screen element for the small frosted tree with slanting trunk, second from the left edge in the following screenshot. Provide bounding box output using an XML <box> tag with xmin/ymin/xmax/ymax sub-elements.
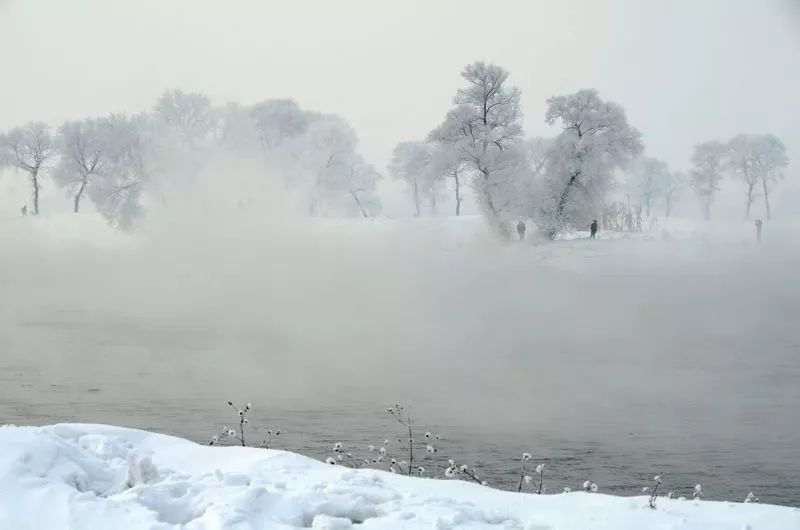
<box><xmin>53</xmin><ymin>119</ymin><xmax>107</xmax><ymax>213</ymax></box>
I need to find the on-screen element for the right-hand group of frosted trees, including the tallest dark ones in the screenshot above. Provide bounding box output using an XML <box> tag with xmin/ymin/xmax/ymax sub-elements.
<box><xmin>389</xmin><ymin>62</ymin><xmax>787</xmax><ymax>238</ymax></box>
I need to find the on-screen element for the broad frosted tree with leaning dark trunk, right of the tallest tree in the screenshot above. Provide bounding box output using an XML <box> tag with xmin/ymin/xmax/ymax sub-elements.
<box><xmin>538</xmin><ymin>90</ymin><xmax>642</xmax><ymax>238</ymax></box>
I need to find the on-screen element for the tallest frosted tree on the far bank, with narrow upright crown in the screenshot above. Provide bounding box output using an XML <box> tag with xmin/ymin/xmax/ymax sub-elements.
<box><xmin>429</xmin><ymin>61</ymin><xmax>522</xmax><ymax>233</ymax></box>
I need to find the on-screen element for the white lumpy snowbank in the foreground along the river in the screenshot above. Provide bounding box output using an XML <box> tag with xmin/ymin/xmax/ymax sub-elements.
<box><xmin>0</xmin><ymin>424</ymin><xmax>800</xmax><ymax>530</ymax></box>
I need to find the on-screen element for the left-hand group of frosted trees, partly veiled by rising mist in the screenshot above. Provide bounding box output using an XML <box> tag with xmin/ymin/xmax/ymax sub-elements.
<box><xmin>0</xmin><ymin>90</ymin><xmax>381</xmax><ymax>228</ymax></box>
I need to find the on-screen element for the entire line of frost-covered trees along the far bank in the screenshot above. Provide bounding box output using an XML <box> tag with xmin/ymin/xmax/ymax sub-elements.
<box><xmin>0</xmin><ymin>61</ymin><xmax>788</xmax><ymax>239</ymax></box>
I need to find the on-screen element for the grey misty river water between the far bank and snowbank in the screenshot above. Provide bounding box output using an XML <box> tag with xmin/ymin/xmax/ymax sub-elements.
<box><xmin>0</xmin><ymin>218</ymin><xmax>800</xmax><ymax>506</ymax></box>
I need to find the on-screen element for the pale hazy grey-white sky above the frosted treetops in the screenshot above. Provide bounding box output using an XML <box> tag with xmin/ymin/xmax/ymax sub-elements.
<box><xmin>0</xmin><ymin>0</ymin><xmax>800</xmax><ymax>175</ymax></box>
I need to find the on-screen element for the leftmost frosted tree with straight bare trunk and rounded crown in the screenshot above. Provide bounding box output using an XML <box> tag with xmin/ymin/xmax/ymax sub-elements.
<box><xmin>0</xmin><ymin>122</ymin><xmax>56</xmax><ymax>215</ymax></box>
